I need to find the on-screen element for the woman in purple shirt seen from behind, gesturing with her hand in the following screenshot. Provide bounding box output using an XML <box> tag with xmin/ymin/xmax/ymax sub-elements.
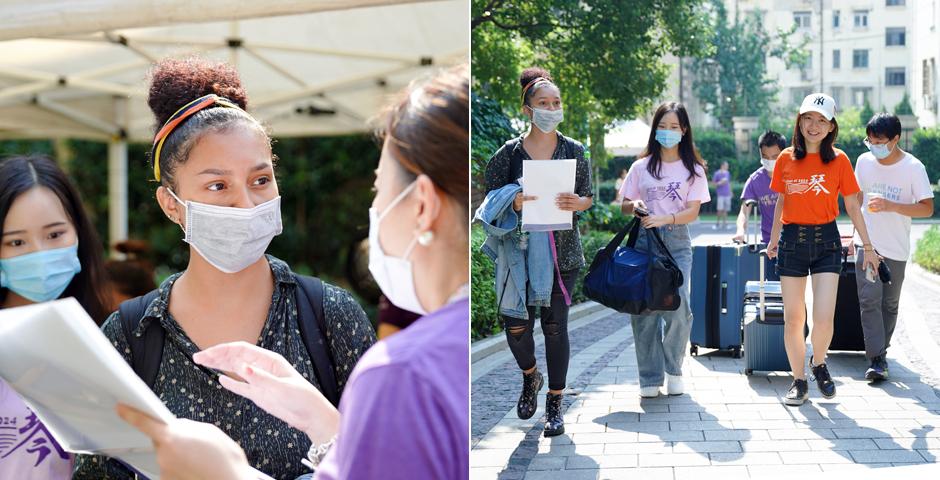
<box><xmin>118</xmin><ymin>66</ymin><xmax>470</xmax><ymax>480</ymax></box>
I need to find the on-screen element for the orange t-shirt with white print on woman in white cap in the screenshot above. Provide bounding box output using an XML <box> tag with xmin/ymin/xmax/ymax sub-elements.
<box><xmin>770</xmin><ymin>147</ymin><xmax>860</xmax><ymax>225</ymax></box>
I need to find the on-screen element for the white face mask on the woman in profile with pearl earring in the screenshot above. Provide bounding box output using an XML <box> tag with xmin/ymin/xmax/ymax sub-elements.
<box><xmin>369</xmin><ymin>182</ymin><xmax>428</xmax><ymax>315</ymax></box>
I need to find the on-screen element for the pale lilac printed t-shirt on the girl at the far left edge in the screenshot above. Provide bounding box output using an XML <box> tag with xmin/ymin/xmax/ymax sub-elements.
<box><xmin>0</xmin><ymin>379</ymin><xmax>72</xmax><ymax>480</ymax></box>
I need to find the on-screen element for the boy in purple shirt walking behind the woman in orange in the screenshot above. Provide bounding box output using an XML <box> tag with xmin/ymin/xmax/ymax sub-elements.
<box><xmin>734</xmin><ymin>130</ymin><xmax>787</xmax><ymax>281</ymax></box>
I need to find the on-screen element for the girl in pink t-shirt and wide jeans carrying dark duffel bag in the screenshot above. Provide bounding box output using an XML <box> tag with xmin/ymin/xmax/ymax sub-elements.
<box><xmin>620</xmin><ymin>102</ymin><xmax>711</xmax><ymax>398</ymax></box>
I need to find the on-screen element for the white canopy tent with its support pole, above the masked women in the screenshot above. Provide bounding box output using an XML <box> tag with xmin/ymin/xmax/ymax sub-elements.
<box><xmin>0</xmin><ymin>0</ymin><xmax>469</xmax><ymax>255</ymax></box>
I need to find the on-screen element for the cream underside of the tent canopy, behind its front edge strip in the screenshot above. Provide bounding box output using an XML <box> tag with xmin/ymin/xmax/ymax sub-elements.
<box><xmin>0</xmin><ymin>0</ymin><xmax>469</xmax><ymax>142</ymax></box>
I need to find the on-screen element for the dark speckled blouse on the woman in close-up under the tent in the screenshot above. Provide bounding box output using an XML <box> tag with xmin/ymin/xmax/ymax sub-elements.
<box><xmin>73</xmin><ymin>255</ymin><xmax>375</xmax><ymax>480</ymax></box>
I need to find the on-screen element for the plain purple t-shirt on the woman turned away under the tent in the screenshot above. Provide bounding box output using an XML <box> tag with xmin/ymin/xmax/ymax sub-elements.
<box><xmin>315</xmin><ymin>299</ymin><xmax>470</xmax><ymax>480</ymax></box>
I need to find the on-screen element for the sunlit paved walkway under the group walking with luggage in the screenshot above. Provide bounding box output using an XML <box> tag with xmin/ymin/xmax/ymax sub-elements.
<box><xmin>470</xmin><ymin>220</ymin><xmax>940</xmax><ymax>479</ymax></box>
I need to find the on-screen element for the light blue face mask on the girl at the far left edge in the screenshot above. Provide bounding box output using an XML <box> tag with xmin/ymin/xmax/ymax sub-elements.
<box><xmin>0</xmin><ymin>242</ymin><xmax>82</xmax><ymax>303</ymax></box>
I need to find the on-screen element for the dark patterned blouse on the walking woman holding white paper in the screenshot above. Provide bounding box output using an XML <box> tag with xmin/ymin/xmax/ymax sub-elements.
<box><xmin>486</xmin><ymin>131</ymin><xmax>594</xmax><ymax>272</ymax></box>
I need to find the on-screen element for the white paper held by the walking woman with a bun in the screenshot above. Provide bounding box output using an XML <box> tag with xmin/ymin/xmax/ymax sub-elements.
<box><xmin>522</xmin><ymin>160</ymin><xmax>577</xmax><ymax>232</ymax></box>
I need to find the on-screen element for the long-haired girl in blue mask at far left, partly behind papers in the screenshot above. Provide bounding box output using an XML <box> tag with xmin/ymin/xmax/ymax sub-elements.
<box><xmin>0</xmin><ymin>157</ymin><xmax>106</xmax><ymax>480</ymax></box>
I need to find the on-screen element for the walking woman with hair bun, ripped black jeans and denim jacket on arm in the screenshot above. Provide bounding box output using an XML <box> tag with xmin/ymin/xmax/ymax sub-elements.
<box><xmin>484</xmin><ymin>67</ymin><xmax>594</xmax><ymax>437</ymax></box>
